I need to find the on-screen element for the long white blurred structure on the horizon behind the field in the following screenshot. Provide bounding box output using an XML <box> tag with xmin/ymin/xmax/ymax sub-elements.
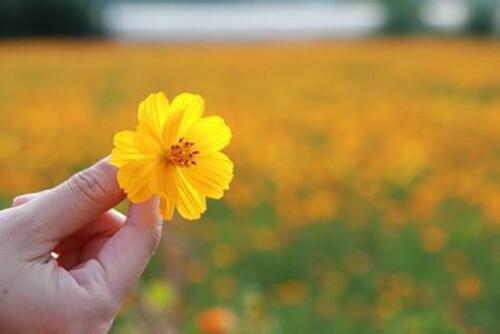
<box><xmin>104</xmin><ymin>2</ymin><xmax>385</xmax><ymax>40</ymax></box>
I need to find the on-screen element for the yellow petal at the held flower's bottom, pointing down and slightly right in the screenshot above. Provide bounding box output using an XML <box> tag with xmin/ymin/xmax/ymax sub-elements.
<box><xmin>175</xmin><ymin>168</ymin><xmax>207</xmax><ymax>220</ymax></box>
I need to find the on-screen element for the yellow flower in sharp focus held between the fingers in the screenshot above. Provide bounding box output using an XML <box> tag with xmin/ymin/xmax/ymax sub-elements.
<box><xmin>110</xmin><ymin>93</ymin><xmax>233</xmax><ymax>220</ymax></box>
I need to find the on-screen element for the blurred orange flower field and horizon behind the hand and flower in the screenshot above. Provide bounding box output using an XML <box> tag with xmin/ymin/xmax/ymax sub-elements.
<box><xmin>0</xmin><ymin>0</ymin><xmax>500</xmax><ymax>334</ymax></box>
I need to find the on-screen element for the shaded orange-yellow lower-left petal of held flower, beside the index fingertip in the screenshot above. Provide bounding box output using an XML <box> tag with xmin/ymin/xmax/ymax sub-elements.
<box><xmin>117</xmin><ymin>159</ymin><xmax>157</xmax><ymax>203</ymax></box>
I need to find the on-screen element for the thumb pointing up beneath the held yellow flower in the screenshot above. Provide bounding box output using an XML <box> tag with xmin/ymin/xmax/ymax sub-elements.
<box><xmin>83</xmin><ymin>197</ymin><xmax>162</xmax><ymax>298</ymax></box>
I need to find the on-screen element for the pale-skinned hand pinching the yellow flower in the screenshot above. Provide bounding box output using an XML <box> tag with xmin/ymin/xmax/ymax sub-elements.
<box><xmin>0</xmin><ymin>160</ymin><xmax>162</xmax><ymax>333</ymax></box>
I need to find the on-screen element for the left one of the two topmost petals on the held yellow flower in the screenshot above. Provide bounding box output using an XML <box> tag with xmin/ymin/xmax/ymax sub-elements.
<box><xmin>138</xmin><ymin>92</ymin><xmax>169</xmax><ymax>142</ymax></box>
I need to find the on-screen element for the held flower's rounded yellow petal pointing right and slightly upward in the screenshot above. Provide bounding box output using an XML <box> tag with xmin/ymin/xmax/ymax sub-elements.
<box><xmin>186</xmin><ymin>116</ymin><xmax>231</xmax><ymax>155</ymax></box>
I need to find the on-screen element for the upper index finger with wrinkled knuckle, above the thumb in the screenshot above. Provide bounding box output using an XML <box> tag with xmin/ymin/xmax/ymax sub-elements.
<box><xmin>19</xmin><ymin>160</ymin><xmax>125</xmax><ymax>242</ymax></box>
